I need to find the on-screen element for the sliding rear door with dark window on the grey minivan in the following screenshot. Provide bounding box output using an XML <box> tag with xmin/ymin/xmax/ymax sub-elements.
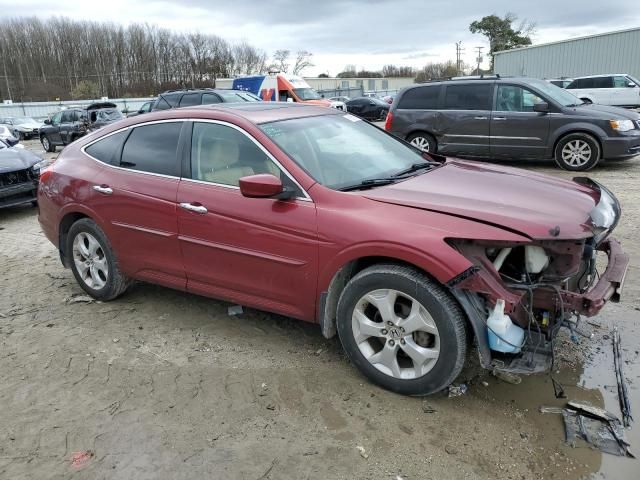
<box><xmin>438</xmin><ymin>81</ymin><xmax>494</xmax><ymax>157</ymax></box>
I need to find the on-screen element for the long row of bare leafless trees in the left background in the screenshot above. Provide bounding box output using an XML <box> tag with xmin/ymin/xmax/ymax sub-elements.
<box><xmin>0</xmin><ymin>17</ymin><xmax>269</xmax><ymax>101</ymax></box>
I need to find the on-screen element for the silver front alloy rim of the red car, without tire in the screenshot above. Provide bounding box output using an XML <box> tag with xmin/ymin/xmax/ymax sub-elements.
<box><xmin>351</xmin><ymin>289</ymin><xmax>440</xmax><ymax>380</ymax></box>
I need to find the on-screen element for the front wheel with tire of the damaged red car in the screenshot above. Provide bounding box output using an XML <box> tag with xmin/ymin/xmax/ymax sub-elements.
<box><xmin>337</xmin><ymin>264</ymin><xmax>468</xmax><ymax>396</ymax></box>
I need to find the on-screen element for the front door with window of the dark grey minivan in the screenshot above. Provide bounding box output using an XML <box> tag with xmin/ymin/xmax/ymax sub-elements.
<box><xmin>490</xmin><ymin>83</ymin><xmax>551</xmax><ymax>159</ymax></box>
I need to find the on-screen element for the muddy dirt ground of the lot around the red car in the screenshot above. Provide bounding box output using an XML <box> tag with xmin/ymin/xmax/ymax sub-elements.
<box><xmin>0</xmin><ymin>142</ymin><xmax>640</xmax><ymax>480</ymax></box>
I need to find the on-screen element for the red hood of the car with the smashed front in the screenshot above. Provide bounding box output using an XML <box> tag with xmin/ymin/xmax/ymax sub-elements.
<box><xmin>362</xmin><ymin>159</ymin><xmax>600</xmax><ymax>240</ymax></box>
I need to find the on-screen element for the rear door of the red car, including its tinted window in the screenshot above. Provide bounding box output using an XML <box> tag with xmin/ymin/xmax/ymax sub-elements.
<box><xmin>84</xmin><ymin>121</ymin><xmax>186</xmax><ymax>289</ymax></box>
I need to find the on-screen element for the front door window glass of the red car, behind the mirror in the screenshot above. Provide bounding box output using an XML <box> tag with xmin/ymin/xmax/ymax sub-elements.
<box><xmin>191</xmin><ymin>122</ymin><xmax>301</xmax><ymax>195</ymax></box>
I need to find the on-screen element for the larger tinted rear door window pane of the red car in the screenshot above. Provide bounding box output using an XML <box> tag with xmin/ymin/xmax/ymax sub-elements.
<box><xmin>120</xmin><ymin>122</ymin><xmax>182</xmax><ymax>177</ymax></box>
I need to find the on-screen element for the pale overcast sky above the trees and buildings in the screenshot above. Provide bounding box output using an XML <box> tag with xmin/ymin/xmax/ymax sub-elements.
<box><xmin>5</xmin><ymin>0</ymin><xmax>640</xmax><ymax>76</ymax></box>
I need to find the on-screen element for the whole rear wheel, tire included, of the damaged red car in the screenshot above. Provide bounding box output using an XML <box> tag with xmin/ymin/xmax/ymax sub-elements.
<box><xmin>66</xmin><ymin>218</ymin><xmax>132</xmax><ymax>301</ymax></box>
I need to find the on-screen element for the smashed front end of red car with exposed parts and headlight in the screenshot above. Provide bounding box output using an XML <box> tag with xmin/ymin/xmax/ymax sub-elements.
<box><xmin>448</xmin><ymin>178</ymin><xmax>629</xmax><ymax>374</ymax></box>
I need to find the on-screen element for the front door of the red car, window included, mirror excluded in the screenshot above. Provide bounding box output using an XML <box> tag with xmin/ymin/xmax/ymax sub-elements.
<box><xmin>178</xmin><ymin>122</ymin><xmax>318</xmax><ymax>320</ymax></box>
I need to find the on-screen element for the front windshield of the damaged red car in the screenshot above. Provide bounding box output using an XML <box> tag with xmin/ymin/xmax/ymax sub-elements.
<box><xmin>260</xmin><ymin>114</ymin><xmax>426</xmax><ymax>190</ymax></box>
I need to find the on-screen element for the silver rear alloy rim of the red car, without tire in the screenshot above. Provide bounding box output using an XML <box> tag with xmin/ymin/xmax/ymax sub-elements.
<box><xmin>73</xmin><ymin>232</ymin><xmax>109</xmax><ymax>290</ymax></box>
